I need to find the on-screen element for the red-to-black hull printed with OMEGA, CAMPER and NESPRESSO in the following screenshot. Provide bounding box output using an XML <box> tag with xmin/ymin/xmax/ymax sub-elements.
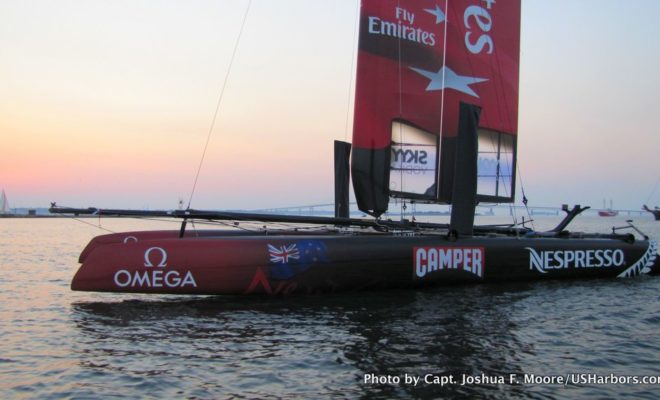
<box><xmin>72</xmin><ymin>231</ymin><xmax>660</xmax><ymax>295</ymax></box>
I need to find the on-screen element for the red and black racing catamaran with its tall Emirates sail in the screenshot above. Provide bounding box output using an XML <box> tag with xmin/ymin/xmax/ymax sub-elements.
<box><xmin>51</xmin><ymin>0</ymin><xmax>660</xmax><ymax>295</ymax></box>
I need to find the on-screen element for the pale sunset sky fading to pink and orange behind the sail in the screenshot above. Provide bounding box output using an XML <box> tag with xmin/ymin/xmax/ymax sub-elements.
<box><xmin>0</xmin><ymin>0</ymin><xmax>660</xmax><ymax>209</ymax></box>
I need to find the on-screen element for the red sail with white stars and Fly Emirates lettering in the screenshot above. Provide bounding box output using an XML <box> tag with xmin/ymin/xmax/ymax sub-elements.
<box><xmin>352</xmin><ymin>0</ymin><xmax>520</xmax><ymax>214</ymax></box>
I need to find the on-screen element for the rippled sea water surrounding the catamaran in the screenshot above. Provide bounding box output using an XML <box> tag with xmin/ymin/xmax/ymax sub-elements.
<box><xmin>0</xmin><ymin>217</ymin><xmax>660</xmax><ymax>399</ymax></box>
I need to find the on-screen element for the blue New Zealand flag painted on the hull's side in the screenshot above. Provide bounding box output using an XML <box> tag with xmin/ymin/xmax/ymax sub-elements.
<box><xmin>268</xmin><ymin>240</ymin><xmax>328</xmax><ymax>280</ymax></box>
